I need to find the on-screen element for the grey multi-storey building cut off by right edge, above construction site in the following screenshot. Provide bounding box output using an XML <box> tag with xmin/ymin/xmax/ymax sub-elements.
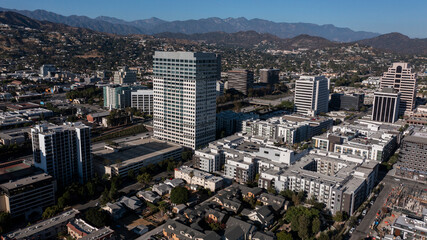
<box><xmin>396</xmin><ymin>127</ymin><xmax>427</xmax><ymax>181</ymax></box>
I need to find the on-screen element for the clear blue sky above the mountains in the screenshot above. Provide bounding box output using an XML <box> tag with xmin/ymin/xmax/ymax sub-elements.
<box><xmin>0</xmin><ymin>0</ymin><xmax>427</xmax><ymax>38</ymax></box>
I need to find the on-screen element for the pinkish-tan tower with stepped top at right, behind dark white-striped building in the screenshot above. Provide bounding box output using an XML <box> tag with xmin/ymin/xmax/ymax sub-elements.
<box><xmin>380</xmin><ymin>63</ymin><xmax>417</xmax><ymax>115</ymax></box>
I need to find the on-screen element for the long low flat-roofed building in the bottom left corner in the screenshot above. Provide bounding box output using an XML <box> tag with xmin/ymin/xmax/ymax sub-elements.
<box><xmin>2</xmin><ymin>209</ymin><xmax>80</xmax><ymax>240</ymax></box>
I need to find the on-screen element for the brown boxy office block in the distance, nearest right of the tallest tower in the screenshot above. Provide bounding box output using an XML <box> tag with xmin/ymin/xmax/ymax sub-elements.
<box><xmin>228</xmin><ymin>69</ymin><xmax>254</xmax><ymax>95</ymax></box>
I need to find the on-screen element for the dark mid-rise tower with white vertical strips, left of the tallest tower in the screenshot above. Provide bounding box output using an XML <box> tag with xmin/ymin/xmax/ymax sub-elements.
<box><xmin>31</xmin><ymin>122</ymin><xmax>93</xmax><ymax>186</ymax></box>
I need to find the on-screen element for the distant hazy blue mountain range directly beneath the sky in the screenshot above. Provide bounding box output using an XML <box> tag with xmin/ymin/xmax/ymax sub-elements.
<box><xmin>0</xmin><ymin>8</ymin><xmax>380</xmax><ymax>42</ymax></box>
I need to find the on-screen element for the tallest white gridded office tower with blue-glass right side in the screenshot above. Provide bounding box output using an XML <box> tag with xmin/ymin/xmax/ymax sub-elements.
<box><xmin>153</xmin><ymin>51</ymin><xmax>221</xmax><ymax>149</ymax></box>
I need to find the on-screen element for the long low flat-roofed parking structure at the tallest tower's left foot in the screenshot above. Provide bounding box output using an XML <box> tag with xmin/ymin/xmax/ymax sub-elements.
<box><xmin>93</xmin><ymin>139</ymin><xmax>182</xmax><ymax>177</ymax></box>
